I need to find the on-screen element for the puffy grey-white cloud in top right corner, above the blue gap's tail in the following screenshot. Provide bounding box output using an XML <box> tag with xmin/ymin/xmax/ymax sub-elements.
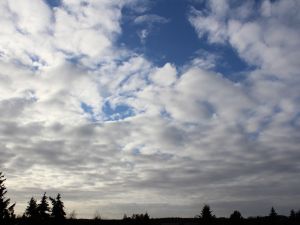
<box><xmin>189</xmin><ymin>1</ymin><xmax>299</xmax><ymax>76</ymax></box>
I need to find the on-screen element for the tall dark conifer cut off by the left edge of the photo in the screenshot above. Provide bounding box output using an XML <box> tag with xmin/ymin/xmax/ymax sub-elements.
<box><xmin>0</xmin><ymin>172</ymin><xmax>16</xmax><ymax>222</ymax></box>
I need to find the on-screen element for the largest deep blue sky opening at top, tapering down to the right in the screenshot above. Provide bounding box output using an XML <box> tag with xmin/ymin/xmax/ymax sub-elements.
<box><xmin>118</xmin><ymin>0</ymin><xmax>254</xmax><ymax>81</ymax></box>
